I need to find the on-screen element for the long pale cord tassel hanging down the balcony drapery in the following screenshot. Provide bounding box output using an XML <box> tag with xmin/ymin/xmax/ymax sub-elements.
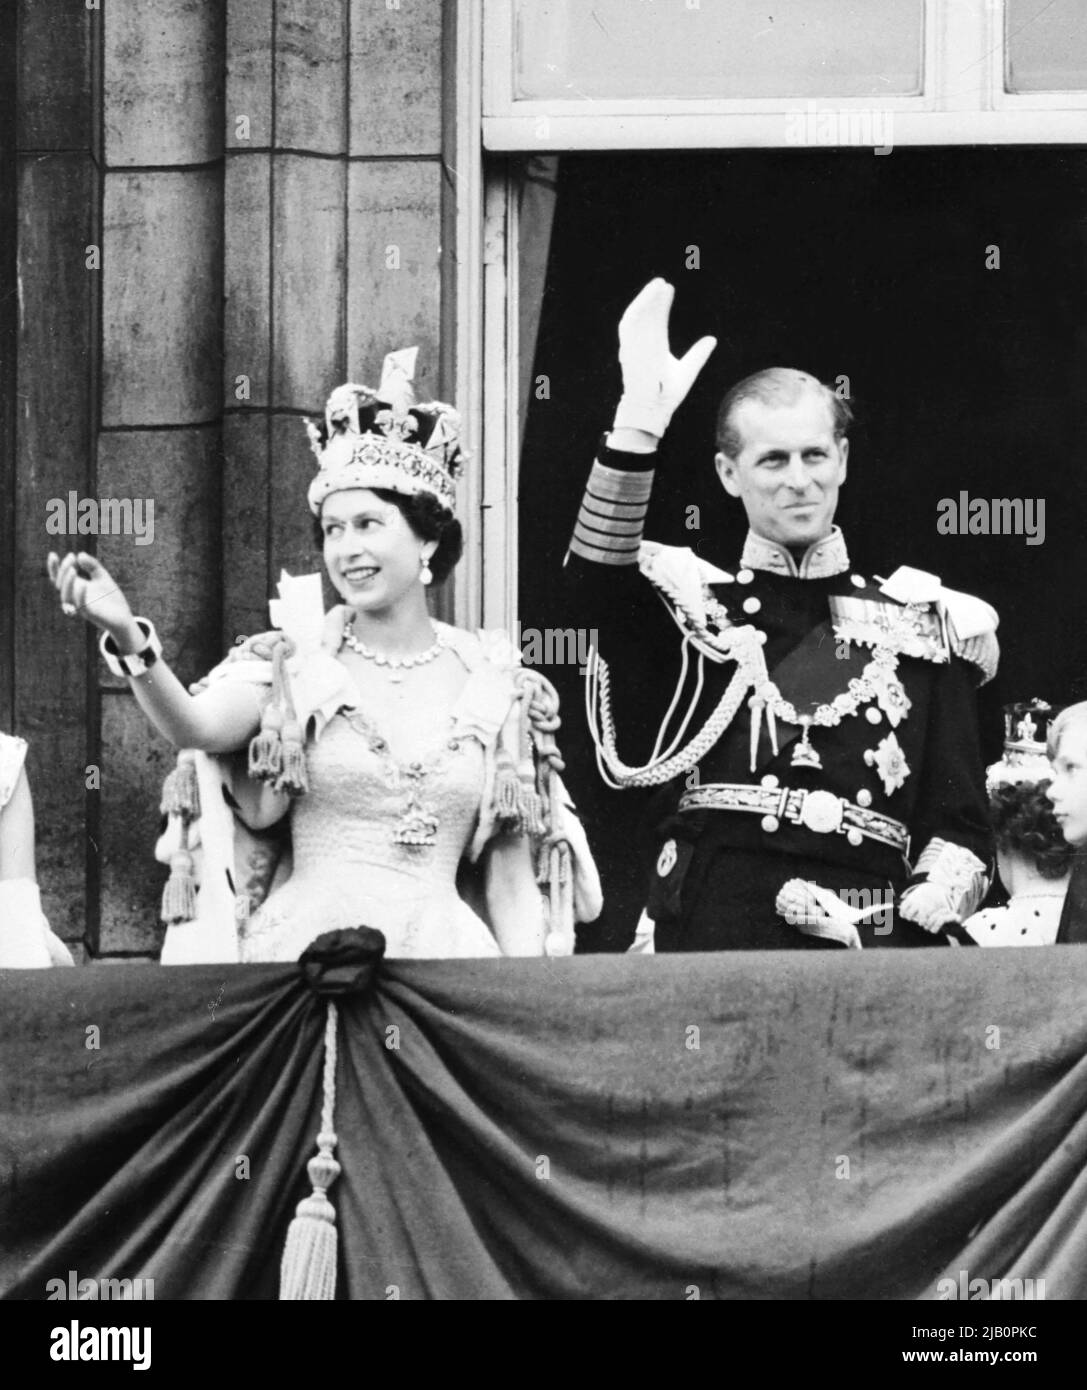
<box><xmin>279</xmin><ymin>1001</ymin><xmax>341</xmax><ymax>1300</ymax></box>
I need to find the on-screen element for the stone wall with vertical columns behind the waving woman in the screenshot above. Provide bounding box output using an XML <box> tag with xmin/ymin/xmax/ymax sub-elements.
<box><xmin>7</xmin><ymin>0</ymin><xmax>453</xmax><ymax>959</ymax></box>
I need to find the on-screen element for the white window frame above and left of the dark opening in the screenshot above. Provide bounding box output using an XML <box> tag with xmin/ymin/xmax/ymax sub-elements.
<box><xmin>455</xmin><ymin>0</ymin><xmax>1087</xmax><ymax>632</ymax></box>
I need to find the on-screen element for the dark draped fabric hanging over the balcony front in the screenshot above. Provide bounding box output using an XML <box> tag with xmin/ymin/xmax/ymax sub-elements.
<box><xmin>0</xmin><ymin>947</ymin><xmax>1087</xmax><ymax>1300</ymax></box>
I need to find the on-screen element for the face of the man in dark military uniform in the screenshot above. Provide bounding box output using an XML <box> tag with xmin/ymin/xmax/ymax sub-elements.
<box><xmin>716</xmin><ymin>391</ymin><xmax>849</xmax><ymax>546</ymax></box>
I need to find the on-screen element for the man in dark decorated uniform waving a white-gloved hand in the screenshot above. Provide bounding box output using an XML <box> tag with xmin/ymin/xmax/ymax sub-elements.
<box><xmin>566</xmin><ymin>279</ymin><xmax>999</xmax><ymax>951</ymax></box>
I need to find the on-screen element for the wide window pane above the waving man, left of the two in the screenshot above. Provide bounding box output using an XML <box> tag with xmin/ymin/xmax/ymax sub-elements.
<box><xmin>514</xmin><ymin>0</ymin><xmax>924</xmax><ymax>101</ymax></box>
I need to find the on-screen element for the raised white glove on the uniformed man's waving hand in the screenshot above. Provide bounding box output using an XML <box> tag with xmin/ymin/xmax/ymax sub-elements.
<box><xmin>614</xmin><ymin>279</ymin><xmax>717</xmax><ymax>439</ymax></box>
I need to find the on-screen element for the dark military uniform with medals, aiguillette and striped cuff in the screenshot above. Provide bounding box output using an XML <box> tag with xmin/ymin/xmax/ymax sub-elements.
<box><xmin>567</xmin><ymin>448</ymin><xmax>997</xmax><ymax>951</ymax></box>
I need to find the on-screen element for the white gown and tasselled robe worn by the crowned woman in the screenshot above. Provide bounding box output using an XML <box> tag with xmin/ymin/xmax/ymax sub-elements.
<box><xmin>156</xmin><ymin>619</ymin><xmax>602</xmax><ymax>965</ymax></box>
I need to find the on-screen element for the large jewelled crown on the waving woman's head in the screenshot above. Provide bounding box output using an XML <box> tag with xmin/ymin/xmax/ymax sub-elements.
<box><xmin>306</xmin><ymin>348</ymin><xmax>466</xmax><ymax>514</ymax></box>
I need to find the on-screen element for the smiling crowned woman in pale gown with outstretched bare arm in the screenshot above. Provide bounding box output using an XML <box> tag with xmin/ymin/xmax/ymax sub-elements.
<box><xmin>49</xmin><ymin>349</ymin><xmax>600</xmax><ymax>963</ymax></box>
